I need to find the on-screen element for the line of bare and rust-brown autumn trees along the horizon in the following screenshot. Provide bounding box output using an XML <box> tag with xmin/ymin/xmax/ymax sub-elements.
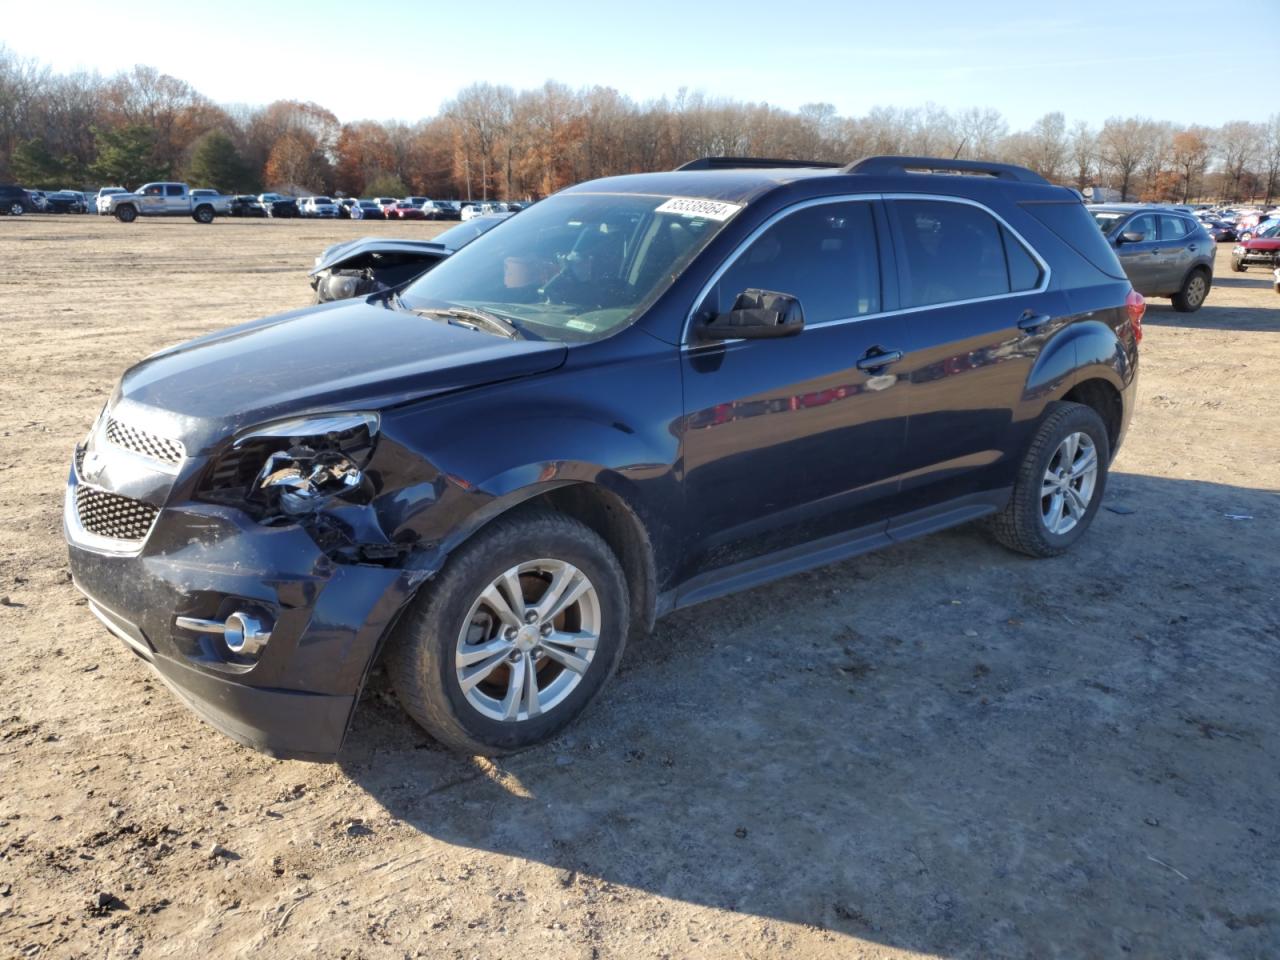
<box><xmin>0</xmin><ymin>45</ymin><xmax>1280</xmax><ymax>204</ymax></box>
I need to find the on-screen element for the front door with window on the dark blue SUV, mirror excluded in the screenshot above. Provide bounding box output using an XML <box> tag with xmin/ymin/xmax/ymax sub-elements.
<box><xmin>682</xmin><ymin>200</ymin><xmax>906</xmax><ymax>576</ymax></box>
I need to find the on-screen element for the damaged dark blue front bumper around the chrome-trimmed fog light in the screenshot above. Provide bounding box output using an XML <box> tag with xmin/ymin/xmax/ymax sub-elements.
<box><xmin>63</xmin><ymin>448</ymin><xmax>422</xmax><ymax>759</ymax></box>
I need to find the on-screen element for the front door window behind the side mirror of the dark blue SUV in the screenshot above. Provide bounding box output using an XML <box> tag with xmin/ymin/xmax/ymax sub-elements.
<box><xmin>703</xmin><ymin>201</ymin><xmax>881</xmax><ymax>325</ymax></box>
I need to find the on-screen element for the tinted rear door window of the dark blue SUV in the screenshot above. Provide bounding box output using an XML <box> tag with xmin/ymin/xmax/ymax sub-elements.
<box><xmin>888</xmin><ymin>200</ymin><xmax>1041</xmax><ymax>307</ymax></box>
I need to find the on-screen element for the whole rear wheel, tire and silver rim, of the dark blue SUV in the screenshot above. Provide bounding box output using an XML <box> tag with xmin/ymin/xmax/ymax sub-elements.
<box><xmin>991</xmin><ymin>402</ymin><xmax>1111</xmax><ymax>557</ymax></box>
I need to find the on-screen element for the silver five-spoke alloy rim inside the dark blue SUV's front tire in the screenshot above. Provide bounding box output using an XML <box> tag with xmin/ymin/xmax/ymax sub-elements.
<box><xmin>454</xmin><ymin>558</ymin><xmax>600</xmax><ymax>722</ymax></box>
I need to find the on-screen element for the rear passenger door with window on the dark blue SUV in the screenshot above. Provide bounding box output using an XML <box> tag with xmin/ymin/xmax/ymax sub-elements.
<box><xmin>886</xmin><ymin>196</ymin><xmax>1068</xmax><ymax>532</ymax></box>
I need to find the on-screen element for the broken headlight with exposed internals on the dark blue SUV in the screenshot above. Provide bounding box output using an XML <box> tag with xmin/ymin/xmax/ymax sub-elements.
<box><xmin>201</xmin><ymin>413</ymin><xmax>379</xmax><ymax>517</ymax></box>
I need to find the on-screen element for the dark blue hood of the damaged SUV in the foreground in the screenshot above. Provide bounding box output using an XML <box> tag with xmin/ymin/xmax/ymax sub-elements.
<box><xmin>113</xmin><ymin>300</ymin><xmax>567</xmax><ymax>453</ymax></box>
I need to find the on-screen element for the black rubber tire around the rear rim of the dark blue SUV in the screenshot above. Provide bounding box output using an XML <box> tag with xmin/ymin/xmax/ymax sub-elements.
<box><xmin>989</xmin><ymin>402</ymin><xmax>1111</xmax><ymax>557</ymax></box>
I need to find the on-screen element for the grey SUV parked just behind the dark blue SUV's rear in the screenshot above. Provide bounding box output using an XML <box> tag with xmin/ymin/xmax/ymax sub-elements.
<box><xmin>1089</xmin><ymin>204</ymin><xmax>1216</xmax><ymax>314</ymax></box>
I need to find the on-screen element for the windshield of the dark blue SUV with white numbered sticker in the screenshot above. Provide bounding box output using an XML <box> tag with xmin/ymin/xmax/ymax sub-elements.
<box><xmin>401</xmin><ymin>193</ymin><xmax>739</xmax><ymax>340</ymax></box>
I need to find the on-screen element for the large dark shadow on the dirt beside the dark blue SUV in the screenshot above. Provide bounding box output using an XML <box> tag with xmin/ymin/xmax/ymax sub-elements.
<box><xmin>342</xmin><ymin>474</ymin><xmax>1280</xmax><ymax>957</ymax></box>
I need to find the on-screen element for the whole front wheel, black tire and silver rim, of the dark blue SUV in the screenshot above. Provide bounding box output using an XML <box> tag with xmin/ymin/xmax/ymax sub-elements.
<box><xmin>387</xmin><ymin>511</ymin><xmax>630</xmax><ymax>756</ymax></box>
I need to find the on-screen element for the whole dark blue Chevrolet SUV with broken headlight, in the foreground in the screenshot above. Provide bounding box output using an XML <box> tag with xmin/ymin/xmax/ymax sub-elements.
<box><xmin>64</xmin><ymin>157</ymin><xmax>1144</xmax><ymax>758</ymax></box>
